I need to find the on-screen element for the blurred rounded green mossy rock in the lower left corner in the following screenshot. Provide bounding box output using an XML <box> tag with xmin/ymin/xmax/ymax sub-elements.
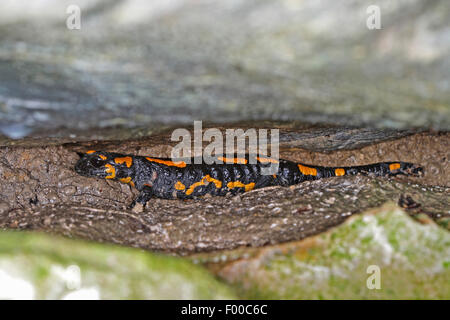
<box><xmin>0</xmin><ymin>232</ymin><xmax>234</xmax><ymax>299</ymax></box>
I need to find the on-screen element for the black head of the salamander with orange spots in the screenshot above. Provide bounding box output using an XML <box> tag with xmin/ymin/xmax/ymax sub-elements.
<box><xmin>75</xmin><ymin>150</ymin><xmax>133</xmax><ymax>179</ymax></box>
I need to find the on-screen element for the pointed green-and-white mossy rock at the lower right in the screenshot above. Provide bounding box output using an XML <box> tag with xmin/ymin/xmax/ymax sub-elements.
<box><xmin>223</xmin><ymin>204</ymin><xmax>450</xmax><ymax>299</ymax></box>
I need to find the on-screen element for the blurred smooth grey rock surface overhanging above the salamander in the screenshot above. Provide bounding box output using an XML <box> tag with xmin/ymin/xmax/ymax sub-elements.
<box><xmin>0</xmin><ymin>0</ymin><xmax>450</xmax><ymax>138</ymax></box>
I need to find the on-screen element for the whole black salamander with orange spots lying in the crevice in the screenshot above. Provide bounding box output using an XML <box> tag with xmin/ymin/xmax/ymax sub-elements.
<box><xmin>75</xmin><ymin>150</ymin><xmax>422</xmax><ymax>207</ymax></box>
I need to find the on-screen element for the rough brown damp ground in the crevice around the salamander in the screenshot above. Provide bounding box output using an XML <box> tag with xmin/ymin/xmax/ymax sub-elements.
<box><xmin>0</xmin><ymin>122</ymin><xmax>450</xmax><ymax>254</ymax></box>
